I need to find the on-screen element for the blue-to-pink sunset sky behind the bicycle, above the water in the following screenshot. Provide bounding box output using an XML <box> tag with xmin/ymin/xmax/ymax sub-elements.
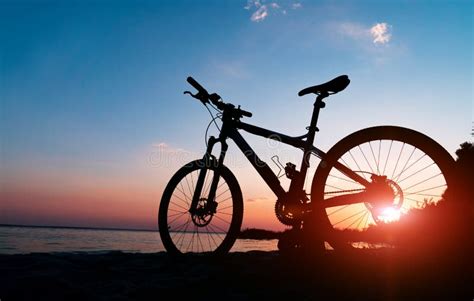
<box><xmin>0</xmin><ymin>0</ymin><xmax>474</xmax><ymax>229</ymax></box>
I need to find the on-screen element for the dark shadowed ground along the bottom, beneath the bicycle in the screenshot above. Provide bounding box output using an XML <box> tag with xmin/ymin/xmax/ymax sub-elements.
<box><xmin>0</xmin><ymin>250</ymin><xmax>474</xmax><ymax>301</ymax></box>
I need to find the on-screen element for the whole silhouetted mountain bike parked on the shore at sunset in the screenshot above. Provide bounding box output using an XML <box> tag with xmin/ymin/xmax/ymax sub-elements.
<box><xmin>158</xmin><ymin>75</ymin><xmax>454</xmax><ymax>254</ymax></box>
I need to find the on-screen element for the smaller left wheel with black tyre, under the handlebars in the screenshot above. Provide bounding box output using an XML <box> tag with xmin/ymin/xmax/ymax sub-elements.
<box><xmin>158</xmin><ymin>160</ymin><xmax>243</xmax><ymax>254</ymax></box>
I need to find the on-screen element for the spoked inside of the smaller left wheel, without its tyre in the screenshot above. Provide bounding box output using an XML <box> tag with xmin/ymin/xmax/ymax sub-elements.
<box><xmin>166</xmin><ymin>169</ymin><xmax>234</xmax><ymax>253</ymax></box>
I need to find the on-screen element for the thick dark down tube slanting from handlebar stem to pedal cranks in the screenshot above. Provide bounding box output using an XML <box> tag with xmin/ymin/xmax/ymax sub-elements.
<box><xmin>229</xmin><ymin>130</ymin><xmax>286</xmax><ymax>199</ymax></box>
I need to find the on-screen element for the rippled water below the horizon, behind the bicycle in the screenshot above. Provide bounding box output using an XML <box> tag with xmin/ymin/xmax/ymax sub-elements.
<box><xmin>0</xmin><ymin>226</ymin><xmax>277</xmax><ymax>254</ymax></box>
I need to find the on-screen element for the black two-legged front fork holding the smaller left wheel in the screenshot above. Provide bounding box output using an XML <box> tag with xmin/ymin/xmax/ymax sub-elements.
<box><xmin>189</xmin><ymin>136</ymin><xmax>229</xmax><ymax>215</ymax></box>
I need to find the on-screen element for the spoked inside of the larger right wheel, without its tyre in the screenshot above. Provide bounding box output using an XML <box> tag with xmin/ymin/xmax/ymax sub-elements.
<box><xmin>323</xmin><ymin>139</ymin><xmax>447</xmax><ymax>247</ymax></box>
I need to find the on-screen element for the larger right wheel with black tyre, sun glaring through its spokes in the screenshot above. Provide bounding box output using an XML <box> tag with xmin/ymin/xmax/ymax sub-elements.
<box><xmin>311</xmin><ymin>126</ymin><xmax>454</xmax><ymax>249</ymax></box>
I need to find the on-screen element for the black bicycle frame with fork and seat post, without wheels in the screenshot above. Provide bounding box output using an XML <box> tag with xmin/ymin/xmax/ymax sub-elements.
<box><xmin>190</xmin><ymin>95</ymin><xmax>370</xmax><ymax>213</ymax></box>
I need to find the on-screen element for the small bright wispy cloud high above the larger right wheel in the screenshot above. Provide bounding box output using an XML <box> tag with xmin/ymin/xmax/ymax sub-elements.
<box><xmin>336</xmin><ymin>22</ymin><xmax>392</xmax><ymax>44</ymax></box>
